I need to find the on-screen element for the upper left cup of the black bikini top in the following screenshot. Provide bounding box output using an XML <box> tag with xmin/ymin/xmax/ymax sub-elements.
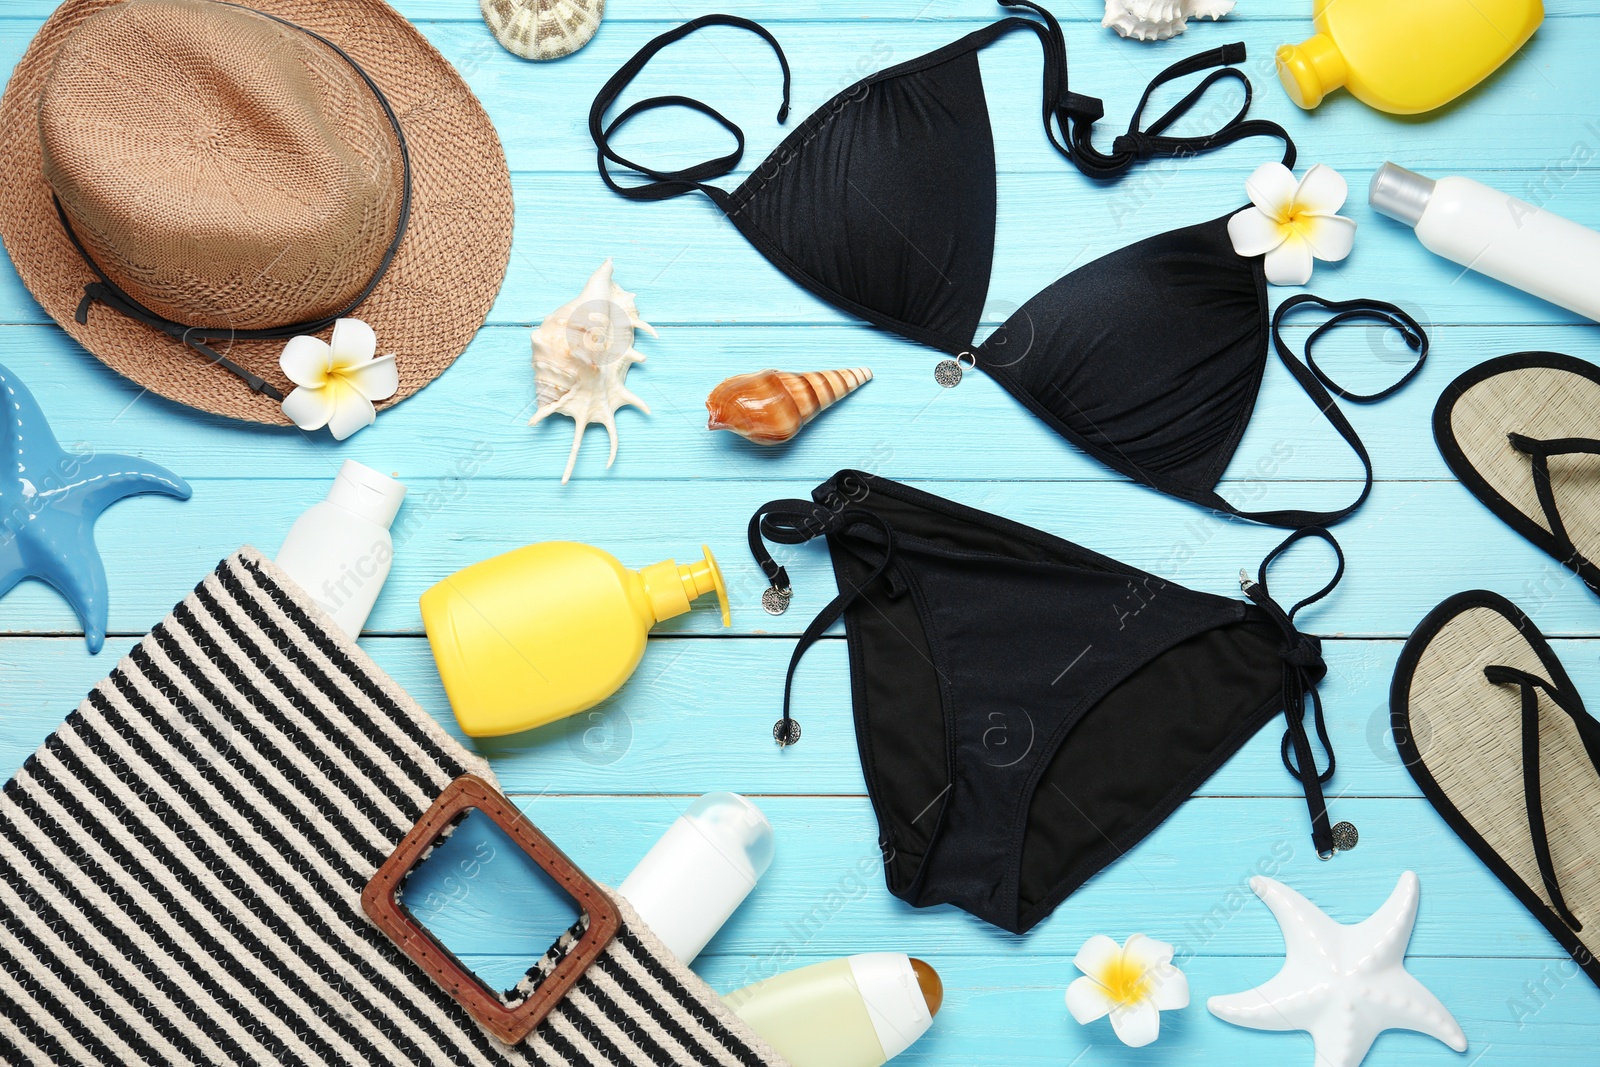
<box><xmin>718</xmin><ymin>50</ymin><xmax>995</xmax><ymax>352</ymax></box>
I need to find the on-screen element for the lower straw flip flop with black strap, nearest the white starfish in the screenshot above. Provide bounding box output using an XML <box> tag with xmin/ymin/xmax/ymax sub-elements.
<box><xmin>1389</xmin><ymin>590</ymin><xmax>1600</xmax><ymax>985</ymax></box>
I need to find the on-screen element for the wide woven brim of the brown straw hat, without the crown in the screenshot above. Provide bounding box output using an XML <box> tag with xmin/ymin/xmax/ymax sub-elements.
<box><xmin>0</xmin><ymin>0</ymin><xmax>512</xmax><ymax>426</ymax></box>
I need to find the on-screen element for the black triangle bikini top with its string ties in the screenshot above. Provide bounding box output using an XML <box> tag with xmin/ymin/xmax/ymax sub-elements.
<box><xmin>589</xmin><ymin>0</ymin><xmax>1427</xmax><ymax>526</ymax></box>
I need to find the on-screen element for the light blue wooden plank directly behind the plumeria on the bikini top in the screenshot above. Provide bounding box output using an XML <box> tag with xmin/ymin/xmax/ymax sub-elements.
<box><xmin>0</xmin><ymin>164</ymin><xmax>1600</xmax><ymax>327</ymax></box>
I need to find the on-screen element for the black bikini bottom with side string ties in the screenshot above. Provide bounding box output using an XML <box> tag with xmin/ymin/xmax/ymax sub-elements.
<box><xmin>750</xmin><ymin>470</ymin><xmax>1344</xmax><ymax>933</ymax></box>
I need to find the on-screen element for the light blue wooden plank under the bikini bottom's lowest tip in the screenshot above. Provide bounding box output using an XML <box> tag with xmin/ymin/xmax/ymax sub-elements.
<box><xmin>384</xmin><ymin>795</ymin><xmax>1574</xmax><ymax>966</ymax></box>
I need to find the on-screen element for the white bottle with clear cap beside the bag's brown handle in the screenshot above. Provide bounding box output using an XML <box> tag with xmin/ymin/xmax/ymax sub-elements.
<box><xmin>618</xmin><ymin>793</ymin><xmax>773</xmax><ymax>965</ymax></box>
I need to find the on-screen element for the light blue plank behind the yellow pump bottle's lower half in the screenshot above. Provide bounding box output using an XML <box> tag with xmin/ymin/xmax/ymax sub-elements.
<box><xmin>12</xmin><ymin>637</ymin><xmax>1600</xmax><ymax>798</ymax></box>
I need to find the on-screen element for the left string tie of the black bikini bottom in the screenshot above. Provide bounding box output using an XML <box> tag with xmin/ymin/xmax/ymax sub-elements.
<box><xmin>749</xmin><ymin>489</ymin><xmax>894</xmax><ymax>749</ymax></box>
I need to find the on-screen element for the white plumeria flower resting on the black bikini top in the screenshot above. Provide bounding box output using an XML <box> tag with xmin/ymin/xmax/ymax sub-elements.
<box><xmin>1227</xmin><ymin>163</ymin><xmax>1355</xmax><ymax>285</ymax></box>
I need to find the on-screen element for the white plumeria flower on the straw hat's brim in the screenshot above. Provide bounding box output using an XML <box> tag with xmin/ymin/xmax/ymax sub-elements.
<box><xmin>278</xmin><ymin>318</ymin><xmax>400</xmax><ymax>442</ymax></box>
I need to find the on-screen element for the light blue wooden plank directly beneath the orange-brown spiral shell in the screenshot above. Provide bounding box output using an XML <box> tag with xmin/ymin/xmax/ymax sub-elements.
<box><xmin>0</xmin><ymin>319</ymin><xmax>1600</xmax><ymax>483</ymax></box>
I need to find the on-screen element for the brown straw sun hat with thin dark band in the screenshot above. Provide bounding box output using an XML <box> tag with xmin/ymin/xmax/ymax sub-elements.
<box><xmin>0</xmin><ymin>0</ymin><xmax>512</xmax><ymax>424</ymax></box>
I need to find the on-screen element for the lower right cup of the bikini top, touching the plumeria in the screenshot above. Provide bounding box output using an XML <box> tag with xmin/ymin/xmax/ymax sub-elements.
<box><xmin>974</xmin><ymin>216</ymin><xmax>1269</xmax><ymax>502</ymax></box>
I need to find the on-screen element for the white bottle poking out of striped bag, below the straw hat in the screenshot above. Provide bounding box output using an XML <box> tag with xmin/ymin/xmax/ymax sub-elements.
<box><xmin>277</xmin><ymin>459</ymin><xmax>405</xmax><ymax>640</ymax></box>
